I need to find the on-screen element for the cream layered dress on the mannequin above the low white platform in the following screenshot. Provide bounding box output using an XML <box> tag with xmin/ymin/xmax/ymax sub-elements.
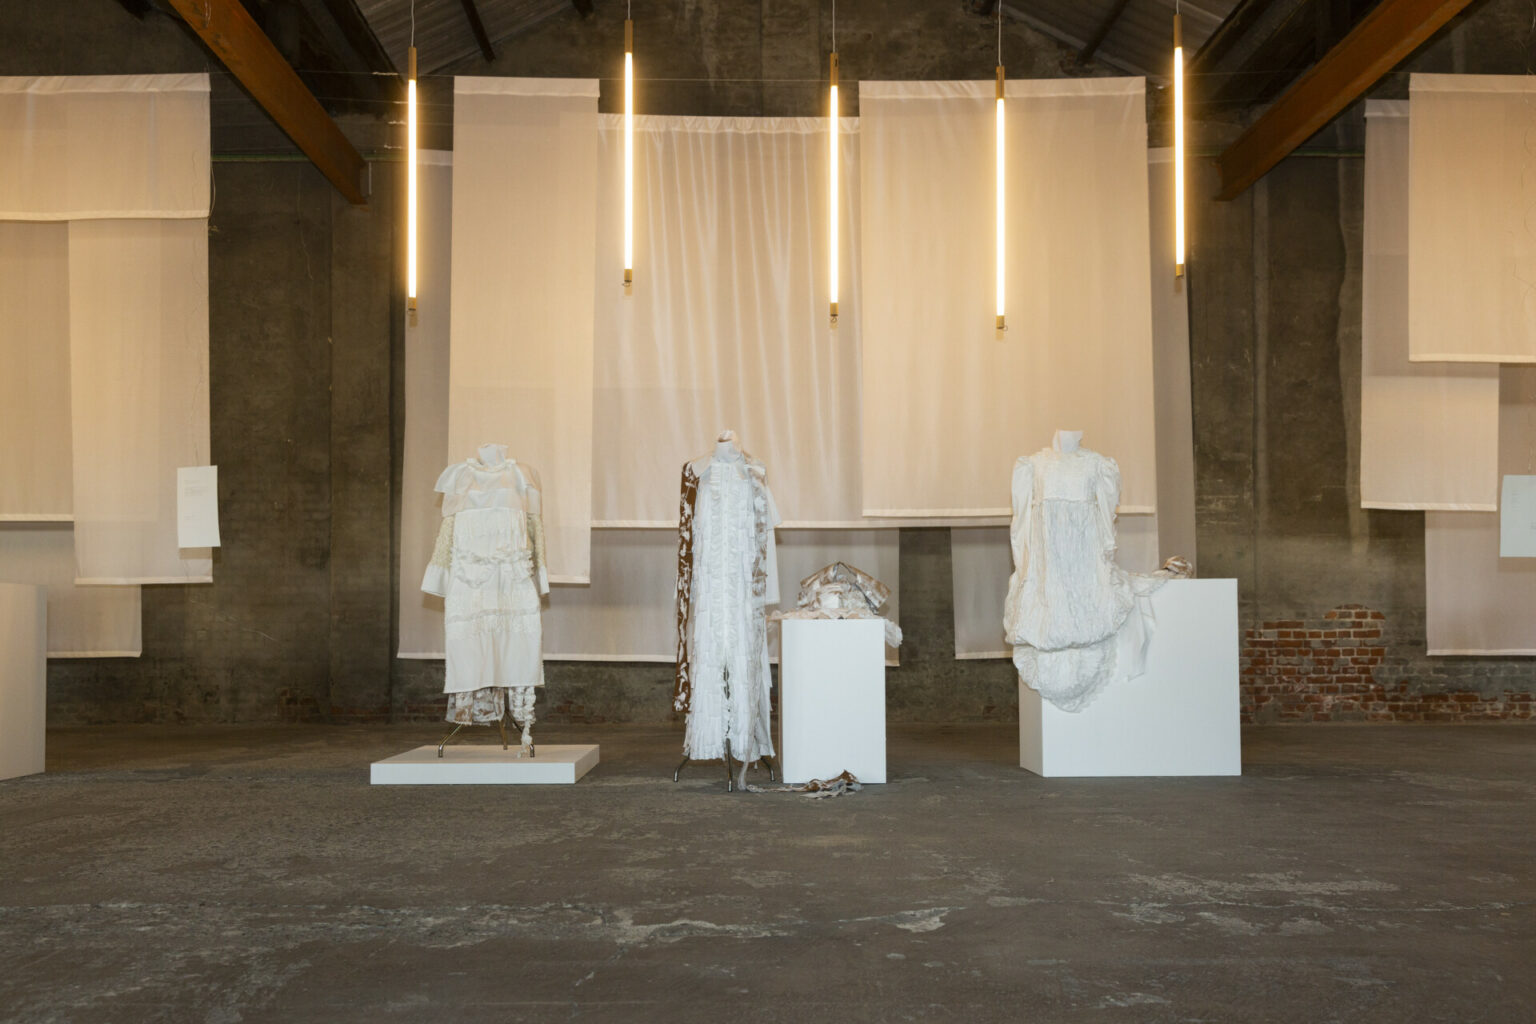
<box><xmin>421</xmin><ymin>445</ymin><xmax>550</xmax><ymax>725</ymax></box>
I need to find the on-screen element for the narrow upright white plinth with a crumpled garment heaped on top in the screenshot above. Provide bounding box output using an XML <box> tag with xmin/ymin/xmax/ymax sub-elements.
<box><xmin>779</xmin><ymin>619</ymin><xmax>885</xmax><ymax>783</ymax></box>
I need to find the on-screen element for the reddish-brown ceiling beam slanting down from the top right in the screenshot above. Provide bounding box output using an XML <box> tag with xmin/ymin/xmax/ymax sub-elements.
<box><xmin>1217</xmin><ymin>0</ymin><xmax>1471</xmax><ymax>200</ymax></box>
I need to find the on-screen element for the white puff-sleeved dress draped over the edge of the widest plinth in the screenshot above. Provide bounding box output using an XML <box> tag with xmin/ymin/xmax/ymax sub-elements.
<box><xmin>1003</xmin><ymin>444</ymin><xmax>1160</xmax><ymax>711</ymax></box>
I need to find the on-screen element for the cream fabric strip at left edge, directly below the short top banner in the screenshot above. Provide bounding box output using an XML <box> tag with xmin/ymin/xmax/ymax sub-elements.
<box><xmin>0</xmin><ymin>221</ymin><xmax>74</xmax><ymax>515</ymax></box>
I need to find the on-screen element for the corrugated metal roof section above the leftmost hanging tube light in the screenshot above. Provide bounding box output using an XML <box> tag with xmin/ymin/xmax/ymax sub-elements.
<box><xmin>356</xmin><ymin>0</ymin><xmax>571</xmax><ymax>75</ymax></box>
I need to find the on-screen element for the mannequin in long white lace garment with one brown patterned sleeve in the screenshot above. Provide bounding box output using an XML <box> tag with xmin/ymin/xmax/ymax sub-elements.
<box><xmin>673</xmin><ymin>430</ymin><xmax>779</xmax><ymax>789</ymax></box>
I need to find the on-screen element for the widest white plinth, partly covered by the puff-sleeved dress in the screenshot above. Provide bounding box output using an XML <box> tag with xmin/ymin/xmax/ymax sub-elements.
<box><xmin>1018</xmin><ymin>579</ymin><xmax>1243</xmax><ymax>777</ymax></box>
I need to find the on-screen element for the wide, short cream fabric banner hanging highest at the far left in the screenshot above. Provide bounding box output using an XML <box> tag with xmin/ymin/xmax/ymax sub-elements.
<box><xmin>0</xmin><ymin>74</ymin><xmax>210</xmax><ymax>221</ymax></box>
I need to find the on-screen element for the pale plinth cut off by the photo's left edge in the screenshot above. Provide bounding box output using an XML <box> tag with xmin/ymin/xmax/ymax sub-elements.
<box><xmin>0</xmin><ymin>583</ymin><xmax>48</xmax><ymax>778</ymax></box>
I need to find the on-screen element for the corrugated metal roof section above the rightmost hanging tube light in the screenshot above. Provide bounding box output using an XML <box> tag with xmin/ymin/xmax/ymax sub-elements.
<box><xmin>1003</xmin><ymin>0</ymin><xmax>1238</xmax><ymax>83</ymax></box>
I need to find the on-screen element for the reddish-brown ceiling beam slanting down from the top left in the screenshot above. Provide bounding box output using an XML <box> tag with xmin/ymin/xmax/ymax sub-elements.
<box><xmin>169</xmin><ymin>0</ymin><xmax>367</xmax><ymax>206</ymax></box>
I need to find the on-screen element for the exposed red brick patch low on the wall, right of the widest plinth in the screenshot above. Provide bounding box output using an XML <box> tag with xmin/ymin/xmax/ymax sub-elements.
<box><xmin>1241</xmin><ymin>605</ymin><xmax>1533</xmax><ymax>723</ymax></box>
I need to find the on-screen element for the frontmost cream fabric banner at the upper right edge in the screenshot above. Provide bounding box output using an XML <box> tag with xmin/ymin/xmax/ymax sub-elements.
<box><xmin>1409</xmin><ymin>75</ymin><xmax>1536</xmax><ymax>362</ymax></box>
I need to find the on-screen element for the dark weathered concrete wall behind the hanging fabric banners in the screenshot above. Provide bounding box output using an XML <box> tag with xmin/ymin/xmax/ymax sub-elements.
<box><xmin>14</xmin><ymin>0</ymin><xmax>1536</xmax><ymax>723</ymax></box>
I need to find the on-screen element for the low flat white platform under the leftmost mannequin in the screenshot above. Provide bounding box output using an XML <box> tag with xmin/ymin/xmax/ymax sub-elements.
<box><xmin>369</xmin><ymin>743</ymin><xmax>598</xmax><ymax>786</ymax></box>
